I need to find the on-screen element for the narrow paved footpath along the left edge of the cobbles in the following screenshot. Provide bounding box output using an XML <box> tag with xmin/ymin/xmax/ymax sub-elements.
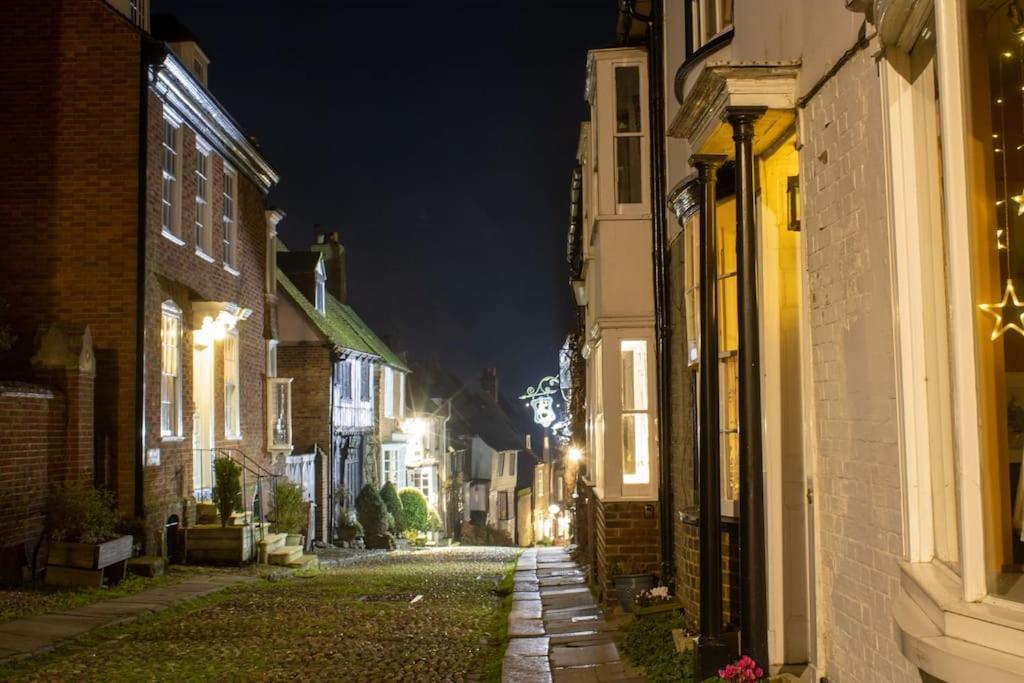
<box><xmin>0</xmin><ymin>574</ymin><xmax>253</xmax><ymax>663</ymax></box>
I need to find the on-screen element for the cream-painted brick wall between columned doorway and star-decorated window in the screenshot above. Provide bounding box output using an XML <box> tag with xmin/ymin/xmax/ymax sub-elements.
<box><xmin>801</xmin><ymin>50</ymin><xmax>919</xmax><ymax>683</ymax></box>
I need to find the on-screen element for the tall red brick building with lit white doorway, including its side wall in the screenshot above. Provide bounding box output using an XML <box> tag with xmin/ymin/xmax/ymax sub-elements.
<box><xmin>0</xmin><ymin>0</ymin><xmax>291</xmax><ymax>554</ymax></box>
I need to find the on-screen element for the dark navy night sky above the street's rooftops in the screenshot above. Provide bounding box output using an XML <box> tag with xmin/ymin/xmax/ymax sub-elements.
<box><xmin>153</xmin><ymin>0</ymin><xmax>616</xmax><ymax>395</ymax></box>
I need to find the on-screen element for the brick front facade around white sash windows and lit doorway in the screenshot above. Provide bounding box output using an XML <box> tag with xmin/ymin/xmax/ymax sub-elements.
<box><xmin>144</xmin><ymin>93</ymin><xmax>274</xmax><ymax>548</ymax></box>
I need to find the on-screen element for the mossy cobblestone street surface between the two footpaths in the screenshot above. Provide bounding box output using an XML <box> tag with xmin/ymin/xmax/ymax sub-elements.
<box><xmin>0</xmin><ymin>548</ymin><xmax>517</xmax><ymax>681</ymax></box>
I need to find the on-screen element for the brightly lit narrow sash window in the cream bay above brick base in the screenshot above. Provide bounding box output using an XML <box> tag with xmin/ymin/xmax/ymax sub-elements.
<box><xmin>620</xmin><ymin>341</ymin><xmax>650</xmax><ymax>484</ymax></box>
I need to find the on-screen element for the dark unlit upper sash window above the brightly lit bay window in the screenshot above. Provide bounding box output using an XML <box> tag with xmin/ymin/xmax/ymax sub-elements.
<box><xmin>614</xmin><ymin>66</ymin><xmax>643</xmax><ymax>204</ymax></box>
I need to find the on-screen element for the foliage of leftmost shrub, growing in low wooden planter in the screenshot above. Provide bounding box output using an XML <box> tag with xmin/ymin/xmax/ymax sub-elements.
<box><xmin>46</xmin><ymin>483</ymin><xmax>118</xmax><ymax>543</ymax></box>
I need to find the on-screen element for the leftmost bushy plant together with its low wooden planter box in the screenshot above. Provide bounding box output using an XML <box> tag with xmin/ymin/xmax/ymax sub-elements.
<box><xmin>46</xmin><ymin>483</ymin><xmax>133</xmax><ymax>586</ymax></box>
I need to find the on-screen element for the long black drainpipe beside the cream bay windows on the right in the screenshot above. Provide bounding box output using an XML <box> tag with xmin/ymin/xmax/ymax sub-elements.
<box><xmin>625</xmin><ymin>0</ymin><xmax>676</xmax><ymax>588</ymax></box>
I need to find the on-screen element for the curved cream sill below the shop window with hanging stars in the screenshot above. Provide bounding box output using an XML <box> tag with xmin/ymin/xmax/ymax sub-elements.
<box><xmin>893</xmin><ymin>562</ymin><xmax>1024</xmax><ymax>681</ymax></box>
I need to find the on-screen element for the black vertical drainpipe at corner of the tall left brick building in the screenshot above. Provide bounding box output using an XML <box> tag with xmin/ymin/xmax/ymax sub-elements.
<box><xmin>134</xmin><ymin>40</ymin><xmax>162</xmax><ymax>519</ymax></box>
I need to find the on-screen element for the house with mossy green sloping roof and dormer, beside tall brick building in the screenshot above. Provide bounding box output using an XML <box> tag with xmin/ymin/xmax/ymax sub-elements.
<box><xmin>276</xmin><ymin>232</ymin><xmax>411</xmax><ymax>543</ymax></box>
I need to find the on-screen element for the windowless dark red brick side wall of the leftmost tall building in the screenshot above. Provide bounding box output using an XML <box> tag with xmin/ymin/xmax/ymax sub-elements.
<box><xmin>0</xmin><ymin>0</ymin><xmax>140</xmax><ymax>509</ymax></box>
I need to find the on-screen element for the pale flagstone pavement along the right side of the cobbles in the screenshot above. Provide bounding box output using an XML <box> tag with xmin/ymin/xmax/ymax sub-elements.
<box><xmin>502</xmin><ymin>548</ymin><xmax>644</xmax><ymax>683</ymax></box>
